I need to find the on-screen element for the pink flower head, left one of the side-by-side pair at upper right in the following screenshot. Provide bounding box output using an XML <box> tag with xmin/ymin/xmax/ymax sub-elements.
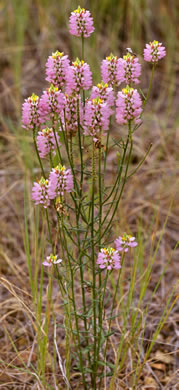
<box><xmin>101</xmin><ymin>53</ymin><xmax>119</xmax><ymax>86</ymax></box>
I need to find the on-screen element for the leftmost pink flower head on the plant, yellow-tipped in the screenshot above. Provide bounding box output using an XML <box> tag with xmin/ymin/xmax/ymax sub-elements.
<box><xmin>22</xmin><ymin>93</ymin><xmax>41</xmax><ymax>129</ymax></box>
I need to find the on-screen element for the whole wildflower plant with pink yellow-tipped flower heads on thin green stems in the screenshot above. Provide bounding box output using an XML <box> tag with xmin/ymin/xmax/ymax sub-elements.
<box><xmin>22</xmin><ymin>7</ymin><xmax>171</xmax><ymax>390</ymax></box>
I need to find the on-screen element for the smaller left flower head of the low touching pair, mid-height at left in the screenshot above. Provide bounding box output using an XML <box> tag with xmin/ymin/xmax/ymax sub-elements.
<box><xmin>32</xmin><ymin>177</ymin><xmax>50</xmax><ymax>209</ymax></box>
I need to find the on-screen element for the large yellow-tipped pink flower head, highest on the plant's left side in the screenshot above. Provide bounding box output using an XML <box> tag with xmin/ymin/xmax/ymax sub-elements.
<box><xmin>46</xmin><ymin>50</ymin><xmax>70</xmax><ymax>89</ymax></box>
